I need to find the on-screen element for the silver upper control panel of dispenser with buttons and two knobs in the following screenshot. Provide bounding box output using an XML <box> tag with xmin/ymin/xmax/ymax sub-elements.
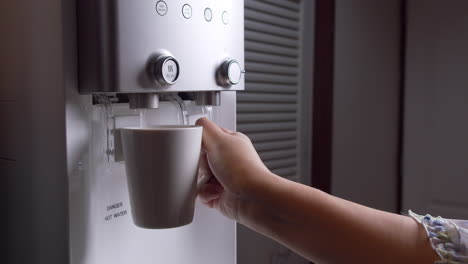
<box><xmin>77</xmin><ymin>0</ymin><xmax>245</xmax><ymax>94</ymax></box>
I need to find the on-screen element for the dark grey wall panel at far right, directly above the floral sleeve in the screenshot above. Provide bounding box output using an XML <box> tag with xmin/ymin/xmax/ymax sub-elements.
<box><xmin>403</xmin><ymin>0</ymin><xmax>468</xmax><ymax>219</ymax></box>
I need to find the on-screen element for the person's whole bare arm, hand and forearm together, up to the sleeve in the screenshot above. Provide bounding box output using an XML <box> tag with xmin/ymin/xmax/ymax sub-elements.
<box><xmin>197</xmin><ymin>119</ymin><xmax>437</xmax><ymax>264</ymax></box>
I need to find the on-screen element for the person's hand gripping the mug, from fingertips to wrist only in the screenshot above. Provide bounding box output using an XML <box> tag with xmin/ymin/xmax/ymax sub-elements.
<box><xmin>196</xmin><ymin>118</ymin><xmax>272</xmax><ymax>221</ymax></box>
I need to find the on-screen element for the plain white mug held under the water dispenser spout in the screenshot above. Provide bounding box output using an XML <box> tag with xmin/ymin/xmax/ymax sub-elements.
<box><xmin>120</xmin><ymin>126</ymin><xmax>202</xmax><ymax>229</ymax></box>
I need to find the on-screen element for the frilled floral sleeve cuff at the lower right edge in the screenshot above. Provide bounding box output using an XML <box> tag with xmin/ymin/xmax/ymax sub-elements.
<box><xmin>409</xmin><ymin>211</ymin><xmax>468</xmax><ymax>264</ymax></box>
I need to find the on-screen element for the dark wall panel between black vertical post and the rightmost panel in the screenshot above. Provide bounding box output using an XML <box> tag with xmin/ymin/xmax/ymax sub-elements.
<box><xmin>331</xmin><ymin>0</ymin><xmax>401</xmax><ymax>211</ymax></box>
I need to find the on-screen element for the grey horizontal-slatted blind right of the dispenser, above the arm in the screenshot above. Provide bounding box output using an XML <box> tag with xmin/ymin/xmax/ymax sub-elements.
<box><xmin>237</xmin><ymin>0</ymin><xmax>301</xmax><ymax>181</ymax></box>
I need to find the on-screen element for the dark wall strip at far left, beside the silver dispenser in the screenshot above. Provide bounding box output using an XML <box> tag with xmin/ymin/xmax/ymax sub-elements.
<box><xmin>0</xmin><ymin>0</ymin><xmax>68</xmax><ymax>264</ymax></box>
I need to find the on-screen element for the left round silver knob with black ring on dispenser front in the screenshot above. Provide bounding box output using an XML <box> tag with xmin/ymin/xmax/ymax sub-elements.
<box><xmin>150</xmin><ymin>56</ymin><xmax>180</xmax><ymax>85</ymax></box>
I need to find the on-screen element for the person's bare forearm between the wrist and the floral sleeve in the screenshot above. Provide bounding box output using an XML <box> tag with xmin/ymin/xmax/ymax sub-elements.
<box><xmin>240</xmin><ymin>172</ymin><xmax>436</xmax><ymax>264</ymax></box>
